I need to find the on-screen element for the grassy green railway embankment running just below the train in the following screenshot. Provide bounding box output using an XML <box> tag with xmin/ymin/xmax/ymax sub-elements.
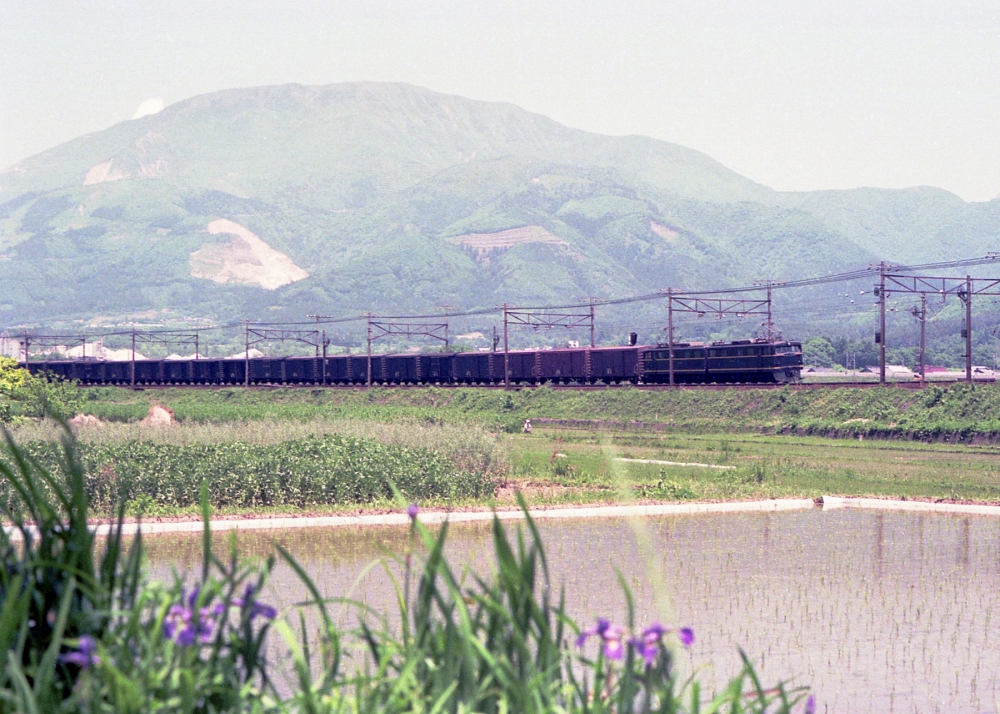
<box><xmin>72</xmin><ymin>384</ymin><xmax>1000</xmax><ymax>443</ymax></box>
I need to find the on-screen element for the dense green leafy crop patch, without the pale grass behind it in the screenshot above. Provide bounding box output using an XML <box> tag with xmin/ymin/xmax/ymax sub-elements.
<box><xmin>7</xmin><ymin>436</ymin><xmax>495</xmax><ymax>515</ymax></box>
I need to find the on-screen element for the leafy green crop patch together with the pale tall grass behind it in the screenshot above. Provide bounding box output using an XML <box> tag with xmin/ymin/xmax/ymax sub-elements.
<box><xmin>7</xmin><ymin>420</ymin><xmax>509</xmax><ymax>516</ymax></box>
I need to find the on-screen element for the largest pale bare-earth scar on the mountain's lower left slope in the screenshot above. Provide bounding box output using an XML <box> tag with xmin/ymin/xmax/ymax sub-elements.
<box><xmin>190</xmin><ymin>219</ymin><xmax>309</xmax><ymax>290</ymax></box>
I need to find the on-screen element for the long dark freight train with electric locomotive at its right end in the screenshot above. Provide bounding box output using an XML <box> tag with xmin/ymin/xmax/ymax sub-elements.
<box><xmin>28</xmin><ymin>340</ymin><xmax>802</xmax><ymax>387</ymax></box>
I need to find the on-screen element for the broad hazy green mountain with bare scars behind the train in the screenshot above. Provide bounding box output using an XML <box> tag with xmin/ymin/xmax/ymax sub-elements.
<box><xmin>0</xmin><ymin>83</ymin><xmax>1000</xmax><ymax>342</ymax></box>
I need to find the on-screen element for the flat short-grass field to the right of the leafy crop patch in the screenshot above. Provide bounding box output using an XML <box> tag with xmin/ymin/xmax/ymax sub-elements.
<box><xmin>510</xmin><ymin>429</ymin><xmax>1000</xmax><ymax>502</ymax></box>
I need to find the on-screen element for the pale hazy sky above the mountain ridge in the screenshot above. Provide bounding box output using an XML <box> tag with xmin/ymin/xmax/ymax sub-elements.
<box><xmin>0</xmin><ymin>0</ymin><xmax>1000</xmax><ymax>201</ymax></box>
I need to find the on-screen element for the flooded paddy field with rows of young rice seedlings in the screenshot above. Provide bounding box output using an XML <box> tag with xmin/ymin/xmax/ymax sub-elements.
<box><xmin>146</xmin><ymin>509</ymin><xmax>1000</xmax><ymax>712</ymax></box>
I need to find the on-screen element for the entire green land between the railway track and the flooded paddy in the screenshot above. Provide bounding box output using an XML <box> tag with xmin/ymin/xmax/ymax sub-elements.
<box><xmin>9</xmin><ymin>385</ymin><xmax>1000</xmax><ymax>515</ymax></box>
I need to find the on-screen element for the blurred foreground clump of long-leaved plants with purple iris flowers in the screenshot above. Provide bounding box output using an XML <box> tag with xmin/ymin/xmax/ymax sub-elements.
<box><xmin>0</xmin><ymin>420</ymin><xmax>814</xmax><ymax>714</ymax></box>
